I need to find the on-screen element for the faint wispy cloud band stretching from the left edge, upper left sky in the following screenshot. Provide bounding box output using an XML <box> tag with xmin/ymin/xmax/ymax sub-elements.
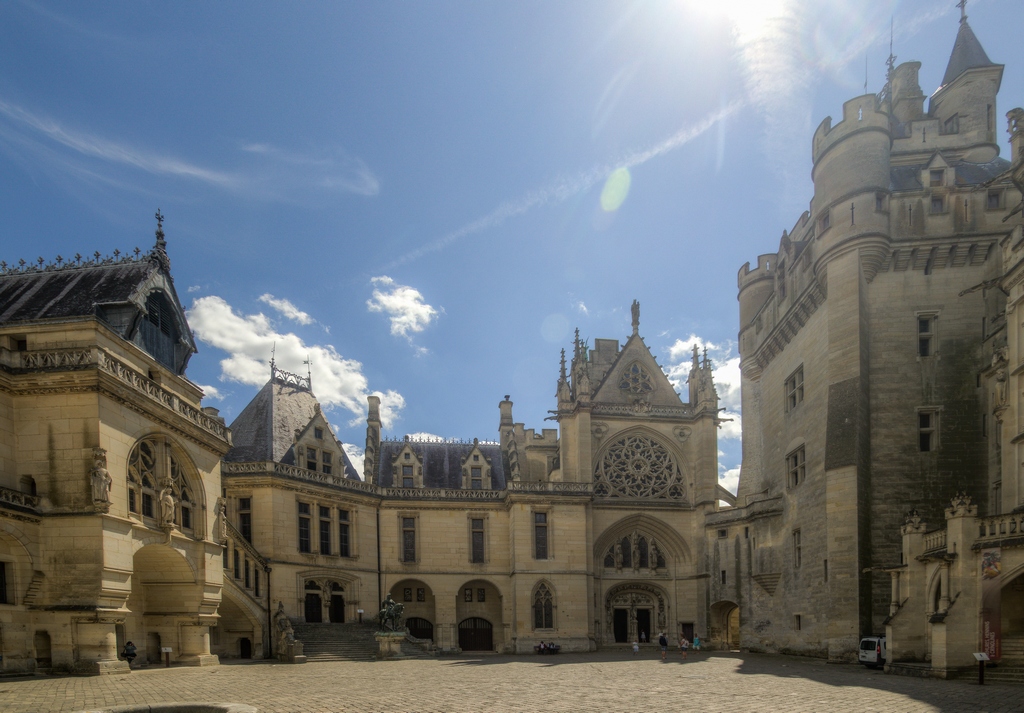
<box><xmin>0</xmin><ymin>98</ymin><xmax>380</xmax><ymax>202</ymax></box>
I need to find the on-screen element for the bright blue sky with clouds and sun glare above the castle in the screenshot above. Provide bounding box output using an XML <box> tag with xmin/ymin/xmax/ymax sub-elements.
<box><xmin>0</xmin><ymin>0</ymin><xmax>1024</xmax><ymax>487</ymax></box>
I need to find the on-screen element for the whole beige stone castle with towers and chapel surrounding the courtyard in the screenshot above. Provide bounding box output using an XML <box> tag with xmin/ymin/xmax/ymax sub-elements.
<box><xmin>0</xmin><ymin>9</ymin><xmax>1024</xmax><ymax>675</ymax></box>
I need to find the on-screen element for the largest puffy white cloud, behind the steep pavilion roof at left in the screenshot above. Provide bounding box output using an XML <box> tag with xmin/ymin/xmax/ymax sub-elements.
<box><xmin>187</xmin><ymin>295</ymin><xmax>406</xmax><ymax>428</ymax></box>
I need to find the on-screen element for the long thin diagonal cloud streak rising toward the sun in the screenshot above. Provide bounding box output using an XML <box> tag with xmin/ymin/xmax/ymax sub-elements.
<box><xmin>380</xmin><ymin>101</ymin><xmax>742</xmax><ymax>267</ymax></box>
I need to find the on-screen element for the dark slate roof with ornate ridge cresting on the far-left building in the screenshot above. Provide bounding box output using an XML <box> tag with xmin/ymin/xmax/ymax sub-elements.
<box><xmin>0</xmin><ymin>258</ymin><xmax>159</xmax><ymax>324</ymax></box>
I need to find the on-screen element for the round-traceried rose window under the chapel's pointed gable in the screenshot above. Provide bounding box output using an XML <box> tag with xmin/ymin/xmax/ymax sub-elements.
<box><xmin>594</xmin><ymin>435</ymin><xmax>684</xmax><ymax>498</ymax></box>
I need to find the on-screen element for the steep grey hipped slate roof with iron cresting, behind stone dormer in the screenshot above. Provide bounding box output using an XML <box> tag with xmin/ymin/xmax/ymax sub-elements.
<box><xmin>224</xmin><ymin>376</ymin><xmax>360</xmax><ymax>480</ymax></box>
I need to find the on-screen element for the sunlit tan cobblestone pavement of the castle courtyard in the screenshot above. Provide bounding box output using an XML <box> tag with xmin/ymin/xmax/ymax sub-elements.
<box><xmin>0</xmin><ymin>651</ymin><xmax>1024</xmax><ymax>713</ymax></box>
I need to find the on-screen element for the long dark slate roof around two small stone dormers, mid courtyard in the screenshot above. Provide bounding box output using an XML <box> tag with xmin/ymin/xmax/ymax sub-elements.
<box><xmin>377</xmin><ymin>441</ymin><xmax>508</xmax><ymax>490</ymax></box>
